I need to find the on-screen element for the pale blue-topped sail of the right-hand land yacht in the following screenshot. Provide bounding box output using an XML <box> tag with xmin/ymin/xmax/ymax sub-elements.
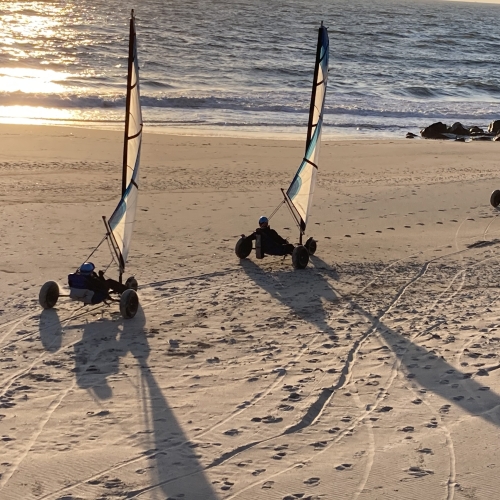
<box><xmin>286</xmin><ymin>23</ymin><xmax>329</xmax><ymax>231</ymax></box>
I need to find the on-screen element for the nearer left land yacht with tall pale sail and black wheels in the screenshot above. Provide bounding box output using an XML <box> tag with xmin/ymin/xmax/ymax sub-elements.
<box><xmin>39</xmin><ymin>10</ymin><xmax>143</xmax><ymax>319</ymax></box>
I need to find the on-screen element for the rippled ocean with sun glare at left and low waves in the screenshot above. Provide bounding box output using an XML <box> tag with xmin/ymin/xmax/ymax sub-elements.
<box><xmin>0</xmin><ymin>0</ymin><xmax>500</xmax><ymax>139</ymax></box>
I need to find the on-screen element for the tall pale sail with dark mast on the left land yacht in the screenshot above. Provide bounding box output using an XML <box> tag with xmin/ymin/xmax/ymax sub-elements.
<box><xmin>108</xmin><ymin>11</ymin><xmax>142</xmax><ymax>271</ymax></box>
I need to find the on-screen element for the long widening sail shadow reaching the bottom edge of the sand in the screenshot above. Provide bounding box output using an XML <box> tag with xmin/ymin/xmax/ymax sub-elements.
<box><xmin>121</xmin><ymin>310</ymin><xmax>217</xmax><ymax>500</ymax></box>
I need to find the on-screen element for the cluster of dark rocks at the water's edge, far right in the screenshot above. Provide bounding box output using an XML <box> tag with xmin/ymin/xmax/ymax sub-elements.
<box><xmin>406</xmin><ymin>120</ymin><xmax>500</xmax><ymax>142</ymax></box>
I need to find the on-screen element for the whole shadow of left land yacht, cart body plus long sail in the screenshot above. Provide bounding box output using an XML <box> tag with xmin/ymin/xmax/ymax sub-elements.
<box><xmin>75</xmin><ymin>308</ymin><xmax>217</xmax><ymax>500</ymax></box>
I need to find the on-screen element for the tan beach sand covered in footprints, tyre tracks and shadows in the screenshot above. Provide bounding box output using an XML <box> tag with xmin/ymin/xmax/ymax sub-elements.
<box><xmin>0</xmin><ymin>125</ymin><xmax>500</xmax><ymax>500</ymax></box>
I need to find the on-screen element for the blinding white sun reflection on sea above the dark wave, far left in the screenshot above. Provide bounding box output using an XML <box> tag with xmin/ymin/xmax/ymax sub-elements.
<box><xmin>0</xmin><ymin>68</ymin><xmax>72</xmax><ymax>93</ymax></box>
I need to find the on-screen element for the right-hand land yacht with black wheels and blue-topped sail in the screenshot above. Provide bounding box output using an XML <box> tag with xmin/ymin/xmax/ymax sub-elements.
<box><xmin>235</xmin><ymin>22</ymin><xmax>329</xmax><ymax>269</ymax></box>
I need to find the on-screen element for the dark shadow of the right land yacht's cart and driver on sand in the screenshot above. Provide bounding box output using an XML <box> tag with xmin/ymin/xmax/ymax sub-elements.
<box><xmin>241</xmin><ymin>259</ymin><xmax>339</xmax><ymax>333</ymax></box>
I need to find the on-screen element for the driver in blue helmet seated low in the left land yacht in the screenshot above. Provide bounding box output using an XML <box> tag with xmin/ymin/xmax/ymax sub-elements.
<box><xmin>68</xmin><ymin>262</ymin><xmax>127</xmax><ymax>304</ymax></box>
